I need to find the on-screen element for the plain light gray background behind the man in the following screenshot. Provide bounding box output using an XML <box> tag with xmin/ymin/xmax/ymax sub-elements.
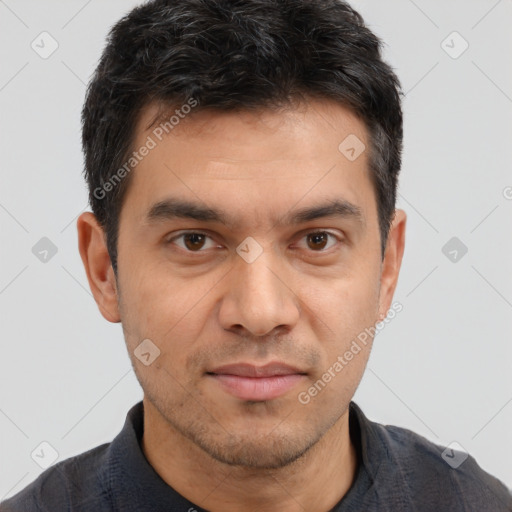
<box><xmin>0</xmin><ymin>0</ymin><xmax>512</xmax><ymax>499</ymax></box>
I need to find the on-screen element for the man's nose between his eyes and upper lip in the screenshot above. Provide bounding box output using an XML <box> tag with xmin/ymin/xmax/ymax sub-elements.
<box><xmin>219</xmin><ymin>246</ymin><xmax>300</xmax><ymax>336</ymax></box>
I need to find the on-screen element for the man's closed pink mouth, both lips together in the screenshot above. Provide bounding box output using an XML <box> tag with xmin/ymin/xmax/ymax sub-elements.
<box><xmin>206</xmin><ymin>362</ymin><xmax>307</xmax><ymax>402</ymax></box>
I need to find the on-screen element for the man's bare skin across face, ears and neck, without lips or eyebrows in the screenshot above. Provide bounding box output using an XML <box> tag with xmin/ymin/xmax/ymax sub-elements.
<box><xmin>77</xmin><ymin>100</ymin><xmax>406</xmax><ymax>512</ymax></box>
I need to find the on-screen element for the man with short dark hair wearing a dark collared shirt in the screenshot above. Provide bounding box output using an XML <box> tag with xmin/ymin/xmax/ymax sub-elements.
<box><xmin>1</xmin><ymin>0</ymin><xmax>512</xmax><ymax>512</ymax></box>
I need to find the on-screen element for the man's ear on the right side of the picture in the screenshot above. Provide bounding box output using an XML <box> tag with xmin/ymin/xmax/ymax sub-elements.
<box><xmin>379</xmin><ymin>210</ymin><xmax>407</xmax><ymax>320</ymax></box>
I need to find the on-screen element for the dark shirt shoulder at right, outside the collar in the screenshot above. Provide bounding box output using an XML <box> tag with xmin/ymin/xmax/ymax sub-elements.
<box><xmin>373</xmin><ymin>423</ymin><xmax>512</xmax><ymax>512</ymax></box>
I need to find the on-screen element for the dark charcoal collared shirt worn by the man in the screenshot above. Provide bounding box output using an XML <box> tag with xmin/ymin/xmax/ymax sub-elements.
<box><xmin>0</xmin><ymin>402</ymin><xmax>512</xmax><ymax>512</ymax></box>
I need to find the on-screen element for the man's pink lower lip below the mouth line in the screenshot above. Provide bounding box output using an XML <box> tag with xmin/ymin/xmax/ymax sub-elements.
<box><xmin>210</xmin><ymin>374</ymin><xmax>305</xmax><ymax>402</ymax></box>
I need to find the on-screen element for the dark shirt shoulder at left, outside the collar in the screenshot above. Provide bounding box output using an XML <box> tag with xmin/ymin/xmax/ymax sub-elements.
<box><xmin>0</xmin><ymin>443</ymin><xmax>110</xmax><ymax>512</ymax></box>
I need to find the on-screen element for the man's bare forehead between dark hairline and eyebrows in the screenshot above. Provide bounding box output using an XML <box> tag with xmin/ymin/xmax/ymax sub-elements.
<box><xmin>123</xmin><ymin>95</ymin><xmax>375</xmax><ymax>230</ymax></box>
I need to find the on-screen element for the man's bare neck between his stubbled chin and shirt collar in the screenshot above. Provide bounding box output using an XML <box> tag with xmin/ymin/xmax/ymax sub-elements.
<box><xmin>142</xmin><ymin>398</ymin><xmax>358</xmax><ymax>512</ymax></box>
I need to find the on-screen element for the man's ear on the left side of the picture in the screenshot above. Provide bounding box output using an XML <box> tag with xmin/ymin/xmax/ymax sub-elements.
<box><xmin>76</xmin><ymin>212</ymin><xmax>121</xmax><ymax>323</ymax></box>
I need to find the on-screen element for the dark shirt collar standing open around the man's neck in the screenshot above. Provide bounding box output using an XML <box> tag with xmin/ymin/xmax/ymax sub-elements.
<box><xmin>106</xmin><ymin>401</ymin><xmax>415</xmax><ymax>512</ymax></box>
